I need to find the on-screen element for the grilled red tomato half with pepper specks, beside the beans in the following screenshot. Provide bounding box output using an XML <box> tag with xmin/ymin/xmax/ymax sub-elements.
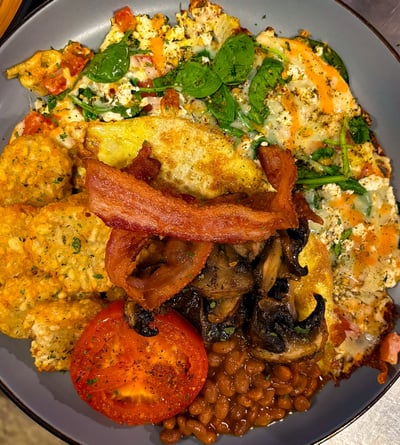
<box><xmin>70</xmin><ymin>301</ymin><xmax>208</xmax><ymax>425</ymax></box>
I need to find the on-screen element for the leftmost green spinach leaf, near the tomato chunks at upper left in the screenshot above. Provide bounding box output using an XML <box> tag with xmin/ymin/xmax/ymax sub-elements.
<box><xmin>85</xmin><ymin>35</ymin><xmax>130</xmax><ymax>83</ymax></box>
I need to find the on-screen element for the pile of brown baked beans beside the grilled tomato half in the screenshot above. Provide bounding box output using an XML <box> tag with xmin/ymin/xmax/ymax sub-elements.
<box><xmin>160</xmin><ymin>336</ymin><xmax>322</xmax><ymax>445</ymax></box>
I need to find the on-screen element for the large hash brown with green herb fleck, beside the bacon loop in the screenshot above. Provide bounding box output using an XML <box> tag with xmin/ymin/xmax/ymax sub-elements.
<box><xmin>26</xmin><ymin>193</ymin><xmax>111</xmax><ymax>293</ymax></box>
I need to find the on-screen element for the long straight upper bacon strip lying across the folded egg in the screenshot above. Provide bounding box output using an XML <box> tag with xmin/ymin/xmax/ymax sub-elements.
<box><xmin>86</xmin><ymin>151</ymin><xmax>298</xmax><ymax>243</ymax></box>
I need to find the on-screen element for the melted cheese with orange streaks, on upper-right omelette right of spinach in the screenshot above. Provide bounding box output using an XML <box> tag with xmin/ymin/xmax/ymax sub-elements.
<box><xmin>257</xmin><ymin>31</ymin><xmax>360</xmax><ymax>153</ymax></box>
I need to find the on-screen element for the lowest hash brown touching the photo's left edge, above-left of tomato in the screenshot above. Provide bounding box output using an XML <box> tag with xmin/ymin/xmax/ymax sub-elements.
<box><xmin>0</xmin><ymin>271</ymin><xmax>66</xmax><ymax>338</ymax></box>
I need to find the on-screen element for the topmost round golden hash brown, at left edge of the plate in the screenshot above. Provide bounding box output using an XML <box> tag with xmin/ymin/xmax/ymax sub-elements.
<box><xmin>0</xmin><ymin>134</ymin><xmax>73</xmax><ymax>206</ymax></box>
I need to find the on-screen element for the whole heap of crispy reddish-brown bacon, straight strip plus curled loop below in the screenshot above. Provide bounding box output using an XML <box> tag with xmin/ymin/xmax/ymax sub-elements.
<box><xmin>86</xmin><ymin>143</ymin><xmax>298</xmax><ymax>310</ymax></box>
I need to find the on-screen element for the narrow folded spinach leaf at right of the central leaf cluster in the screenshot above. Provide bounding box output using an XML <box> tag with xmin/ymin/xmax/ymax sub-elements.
<box><xmin>249</xmin><ymin>57</ymin><xmax>284</xmax><ymax>124</ymax></box>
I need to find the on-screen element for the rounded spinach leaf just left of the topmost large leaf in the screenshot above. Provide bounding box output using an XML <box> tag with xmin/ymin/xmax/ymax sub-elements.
<box><xmin>175</xmin><ymin>61</ymin><xmax>222</xmax><ymax>99</ymax></box>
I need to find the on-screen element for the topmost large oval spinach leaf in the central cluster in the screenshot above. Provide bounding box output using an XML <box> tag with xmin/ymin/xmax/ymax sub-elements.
<box><xmin>213</xmin><ymin>33</ymin><xmax>255</xmax><ymax>85</ymax></box>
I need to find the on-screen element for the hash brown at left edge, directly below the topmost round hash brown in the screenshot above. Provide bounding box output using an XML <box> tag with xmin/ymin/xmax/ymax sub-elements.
<box><xmin>0</xmin><ymin>204</ymin><xmax>37</xmax><ymax>285</ymax></box>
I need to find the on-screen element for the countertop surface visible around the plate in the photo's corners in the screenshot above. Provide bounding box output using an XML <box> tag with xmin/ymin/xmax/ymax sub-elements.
<box><xmin>0</xmin><ymin>0</ymin><xmax>400</xmax><ymax>445</ymax></box>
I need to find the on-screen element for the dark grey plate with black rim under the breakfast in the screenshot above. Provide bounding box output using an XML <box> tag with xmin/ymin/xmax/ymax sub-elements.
<box><xmin>0</xmin><ymin>0</ymin><xmax>400</xmax><ymax>445</ymax></box>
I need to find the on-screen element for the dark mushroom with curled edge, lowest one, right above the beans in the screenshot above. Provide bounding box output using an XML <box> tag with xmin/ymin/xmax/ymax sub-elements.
<box><xmin>249</xmin><ymin>294</ymin><xmax>327</xmax><ymax>363</ymax></box>
